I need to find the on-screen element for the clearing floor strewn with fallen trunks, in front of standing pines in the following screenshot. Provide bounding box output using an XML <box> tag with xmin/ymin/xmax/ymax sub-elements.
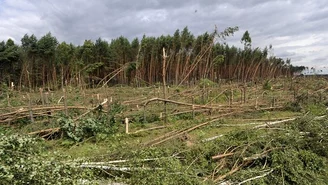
<box><xmin>0</xmin><ymin>77</ymin><xmax>328</xmax><ymax>184</ymax></box>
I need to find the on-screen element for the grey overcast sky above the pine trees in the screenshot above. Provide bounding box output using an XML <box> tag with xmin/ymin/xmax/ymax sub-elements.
<box><xmin>0</xmin><ymin>0</ymin><xmax>328</xmax><ymax>67</ymax></box>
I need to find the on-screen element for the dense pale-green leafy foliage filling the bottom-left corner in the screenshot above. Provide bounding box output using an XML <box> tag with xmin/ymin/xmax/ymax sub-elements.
<box><xmin>0</xmin><ymin>135</ymin><xmax>94</xmax><ymax>185</ymax></box>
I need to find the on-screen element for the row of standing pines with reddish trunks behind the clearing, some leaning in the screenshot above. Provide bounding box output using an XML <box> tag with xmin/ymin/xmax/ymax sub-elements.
<box><xmin>0</xmin><ymin>27</ymin><xmax>304</xmax><ymax>90</ymax></box>
